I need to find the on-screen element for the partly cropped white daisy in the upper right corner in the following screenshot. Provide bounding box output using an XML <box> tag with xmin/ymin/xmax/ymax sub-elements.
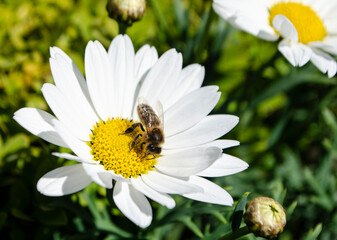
<box><xmin>213</xmin><ymin>0</ymin><xmax>337</xmax><ymax>78</ymax></box>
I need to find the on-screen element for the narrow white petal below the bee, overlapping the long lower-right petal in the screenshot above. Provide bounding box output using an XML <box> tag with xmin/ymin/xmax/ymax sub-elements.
<box><xmin>142</xmin><ymin>171</ymin><xmax>202</xmax><ymax>194</ymax></box>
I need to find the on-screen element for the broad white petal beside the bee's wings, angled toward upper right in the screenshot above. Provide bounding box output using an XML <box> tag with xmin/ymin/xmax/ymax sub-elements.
<box><xmin>164</xmin><ymin>86</ymin><xmax>221</xmax><ymax>137</ymax></box>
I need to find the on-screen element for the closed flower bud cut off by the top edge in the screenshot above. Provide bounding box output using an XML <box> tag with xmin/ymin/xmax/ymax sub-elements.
<box><xmin>106</xmin><ymin>0</ymin><xmax>146</xmax><ymax>24</ymax></box>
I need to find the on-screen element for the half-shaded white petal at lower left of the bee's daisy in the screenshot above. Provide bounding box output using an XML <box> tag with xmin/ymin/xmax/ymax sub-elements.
<box><xmin>37</xmin><ymin>164</ymin><xmax>92</xmax><ymax>197</ymax></box>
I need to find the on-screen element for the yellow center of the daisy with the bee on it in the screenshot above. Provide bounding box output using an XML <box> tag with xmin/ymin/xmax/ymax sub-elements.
<box><xmin>88</xmin><ymin>118</ymin><xmax>159</xmax><ymax>178</ymax></box>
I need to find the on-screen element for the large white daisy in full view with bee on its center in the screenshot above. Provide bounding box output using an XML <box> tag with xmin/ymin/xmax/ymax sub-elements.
<box><xmin>14</xmin><ymin>35</ymin><xmax>248</xmax><ymax>228</ymax></box>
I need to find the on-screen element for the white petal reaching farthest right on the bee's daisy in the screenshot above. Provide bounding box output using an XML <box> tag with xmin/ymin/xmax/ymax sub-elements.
<box><xmin>197</xmin><ymin>154</ymin><xmax>248</xmax><ymax>177</ymax></box>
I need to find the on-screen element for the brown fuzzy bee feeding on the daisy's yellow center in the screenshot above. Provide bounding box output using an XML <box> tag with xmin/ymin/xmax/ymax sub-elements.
<box><xmin>124</xmin><ymin>97</ymin><xmax>164</xmax><ymax>157</ymax></box>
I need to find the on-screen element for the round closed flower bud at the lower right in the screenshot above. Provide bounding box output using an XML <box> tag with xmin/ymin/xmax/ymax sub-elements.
<box><xmin>244</xmin><ymin>197</ymin><xmax>286</xmax><ymax>238</ymax></box>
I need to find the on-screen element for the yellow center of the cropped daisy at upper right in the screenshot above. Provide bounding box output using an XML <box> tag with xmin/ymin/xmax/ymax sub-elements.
<box><xmin>269</xmin><ymin>2</ymin><xmax>326</xmax><ymax>44</ymax></box>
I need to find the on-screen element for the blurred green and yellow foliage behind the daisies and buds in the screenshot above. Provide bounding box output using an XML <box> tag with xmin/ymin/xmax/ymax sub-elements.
<box><xmin>0</xmin><ymin>0</ymin><xmax>337</xmax><ymax>240</ymax></box>
